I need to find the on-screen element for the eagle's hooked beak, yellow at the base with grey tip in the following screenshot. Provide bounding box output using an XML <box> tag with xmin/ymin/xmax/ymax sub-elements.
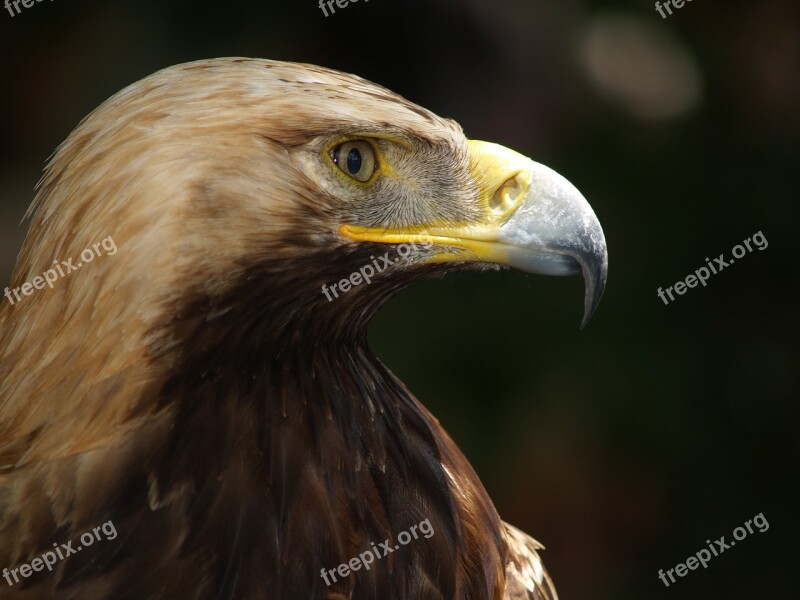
<box><xmin>339</xmin><ymin>141</ymin><xmax>608</xmax><ymax>328</ymax></box>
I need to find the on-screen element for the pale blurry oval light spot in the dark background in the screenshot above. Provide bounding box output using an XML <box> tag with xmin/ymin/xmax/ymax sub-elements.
<box><xmin>579</xmin><ymin>15</ymin><xmax>702</xmax><ymax>119</ymax></box>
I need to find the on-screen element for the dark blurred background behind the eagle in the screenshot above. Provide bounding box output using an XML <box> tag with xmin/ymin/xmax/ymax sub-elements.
<box><xmin>0</xmin><ymin>0</ymin><xmax>800</xmax><ymax>600</ymax></box>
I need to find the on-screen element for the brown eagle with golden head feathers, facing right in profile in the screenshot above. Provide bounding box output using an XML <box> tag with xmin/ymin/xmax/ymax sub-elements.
<box><xmin>0</xmin><ymin>58</ymin><xmax>607</xmax><ymax>600</ymax></box>
